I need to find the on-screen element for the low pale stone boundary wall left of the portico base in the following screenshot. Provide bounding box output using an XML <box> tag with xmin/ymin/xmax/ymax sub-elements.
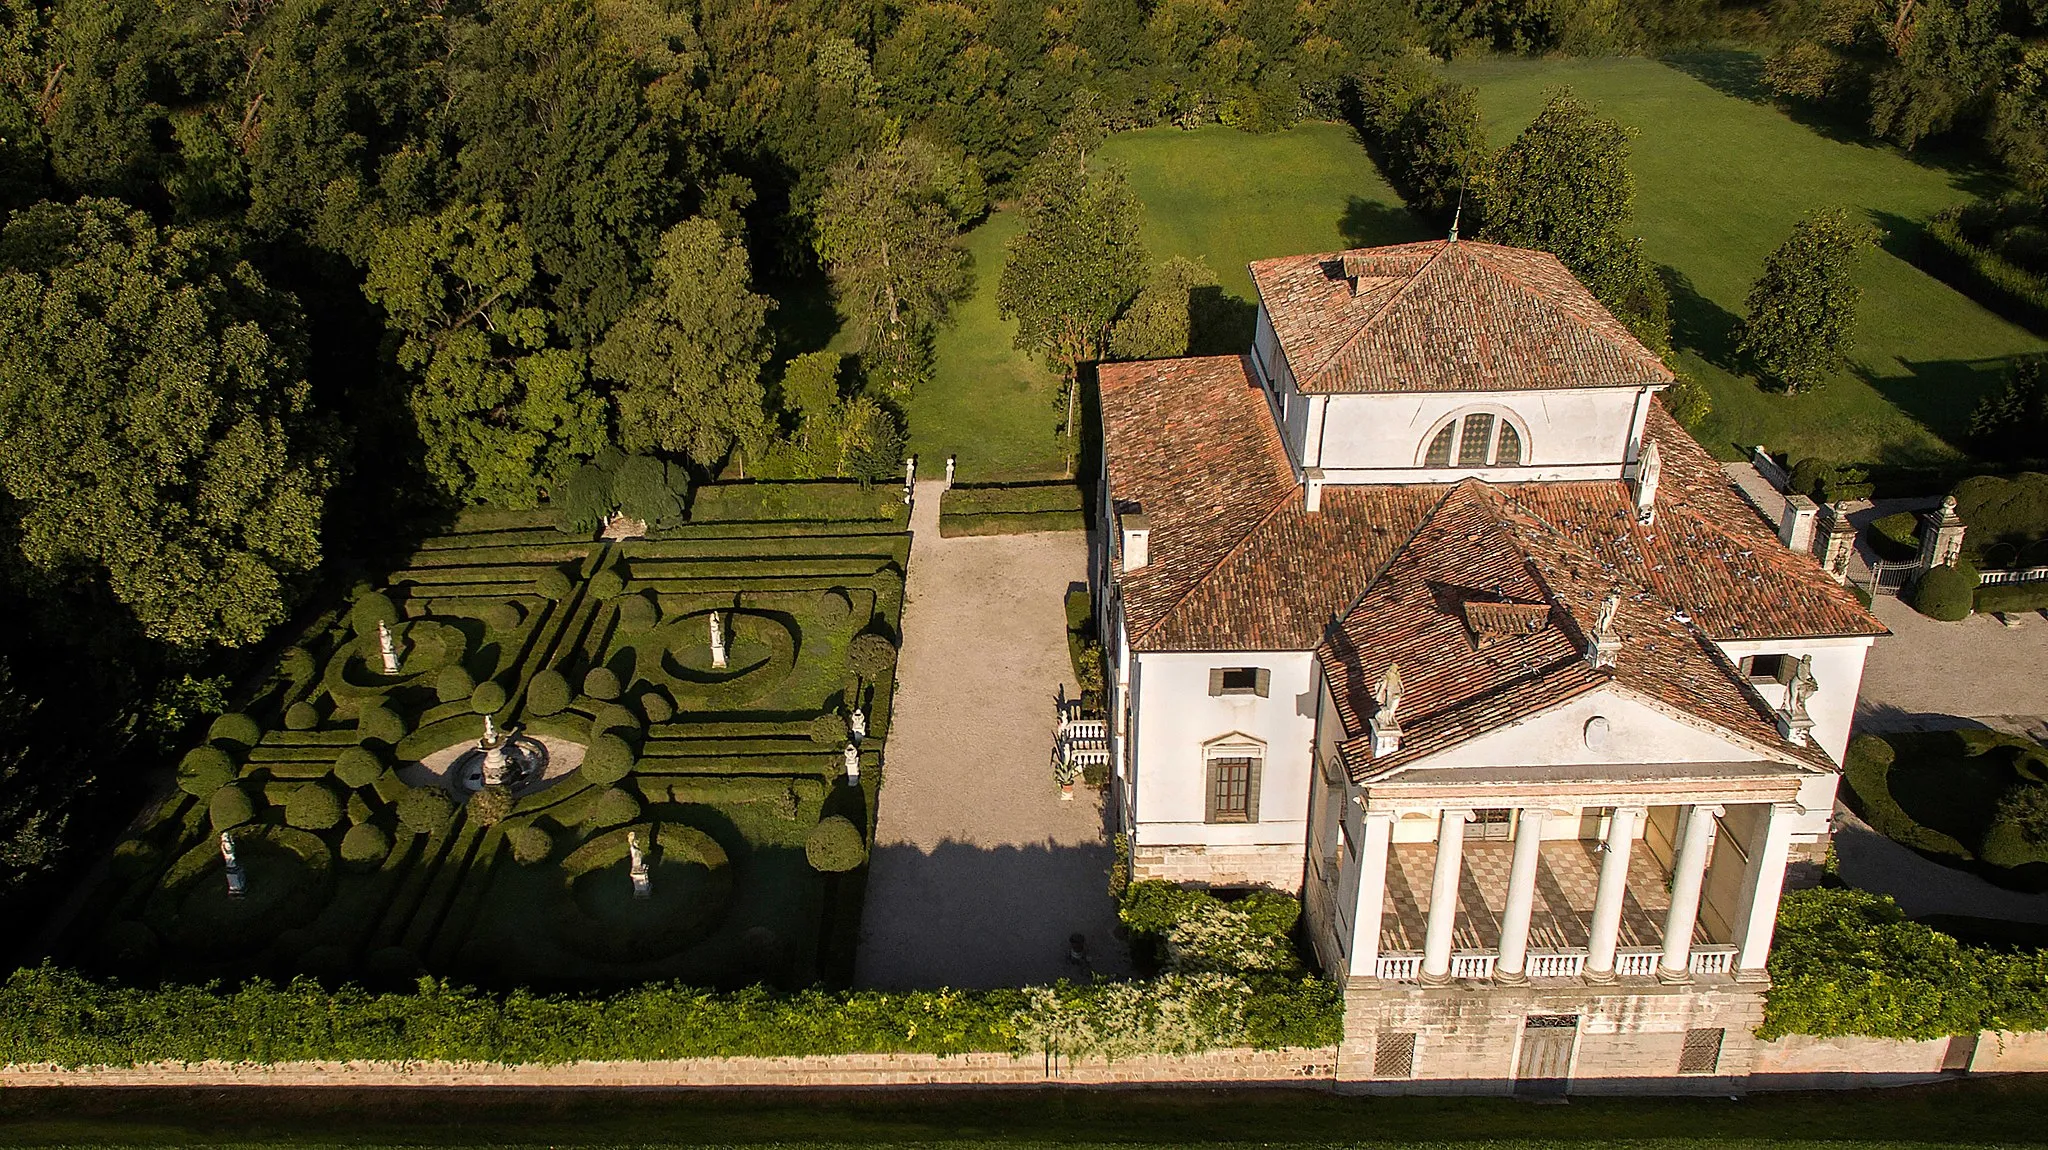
<box><xmin>0</xmin><ymin>1046</ymin><xmax>1337</xmax><ymax>1089</ymax></box>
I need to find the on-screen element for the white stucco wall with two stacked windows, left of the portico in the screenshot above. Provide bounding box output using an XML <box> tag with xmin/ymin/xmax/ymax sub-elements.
<box><xmin>1130</xmin><ymin>651</ymin><xmax>1315</xmax><ymax>849</ymax></box>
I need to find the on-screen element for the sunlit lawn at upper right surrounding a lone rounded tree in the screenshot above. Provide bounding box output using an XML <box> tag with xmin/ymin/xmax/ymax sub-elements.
<box><xmin>1450</xmin><ymin>53</ymin><xmax>2048</xmax><ymax>465</ymax></box>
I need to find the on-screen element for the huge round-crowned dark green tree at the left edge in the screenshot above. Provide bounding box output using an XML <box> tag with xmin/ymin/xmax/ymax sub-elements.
<box><xmin>0</xmin><ymin>201</ymin><xmax>328</xmax><ymax>649</ymax></box>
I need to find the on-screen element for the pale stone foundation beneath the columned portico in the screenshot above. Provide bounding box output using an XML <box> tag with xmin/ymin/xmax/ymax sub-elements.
<box><xmin>1337</xmin><ymin>978</ymin><xmax>1763</xmax><ymax>1095</ymax></box>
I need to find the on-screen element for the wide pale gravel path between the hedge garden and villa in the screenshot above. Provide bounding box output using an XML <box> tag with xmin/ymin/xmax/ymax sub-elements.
<box><xmin>854</xmin><ymin>481</ymin><xmax>1124</xmax><ymax>988</ymax></box>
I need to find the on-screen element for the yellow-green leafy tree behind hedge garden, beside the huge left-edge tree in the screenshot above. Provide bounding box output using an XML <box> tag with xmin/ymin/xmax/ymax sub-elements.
<box><xmin>362</xmin><ymin>203</ymin><xmax>604</xmax><ymax>507</ymax></box>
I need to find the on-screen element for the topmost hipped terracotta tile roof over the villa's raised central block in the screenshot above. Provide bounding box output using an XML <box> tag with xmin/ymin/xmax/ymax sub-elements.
<box><xmin>1251</xmin><ymin>239</ymin><xmax>1673</xmax><ymax>393</ymax></box>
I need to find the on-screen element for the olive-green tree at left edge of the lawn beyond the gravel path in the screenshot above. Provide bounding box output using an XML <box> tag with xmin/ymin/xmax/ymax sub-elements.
<box><xmin>815</xmin><ymin>139</ymin><xmax>985</xmax><ymax>393</ymax></box>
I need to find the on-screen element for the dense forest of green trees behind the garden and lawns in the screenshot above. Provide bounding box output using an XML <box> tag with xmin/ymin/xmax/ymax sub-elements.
<box><xmin>0</xmin><ymin>0</ymin><xmax>2048</xmax><ymax>920</ymax></box>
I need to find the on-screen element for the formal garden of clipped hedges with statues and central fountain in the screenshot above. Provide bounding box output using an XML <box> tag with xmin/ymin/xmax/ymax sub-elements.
<box><xmin>59</xmin><ymin>485</ymin><xmax>909</xmax><ymax>988</ymax></box>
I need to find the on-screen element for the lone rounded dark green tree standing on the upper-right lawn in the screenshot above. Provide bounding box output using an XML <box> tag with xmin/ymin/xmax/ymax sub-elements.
<box><xmin>1737</xmin><ymin>209</ymin><xmax>1876</xmax><ymax>393</ymax></box>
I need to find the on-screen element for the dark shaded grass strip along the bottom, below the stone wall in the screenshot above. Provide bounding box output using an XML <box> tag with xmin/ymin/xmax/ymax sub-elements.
<box><xmin>12</xmin><ymin>1076</ymin><xmax>2048</xmax><ymax>1150</ymax></box>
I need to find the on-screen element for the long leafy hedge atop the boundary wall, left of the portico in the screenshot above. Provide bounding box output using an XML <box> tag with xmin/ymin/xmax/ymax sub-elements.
<box><xmin>0</xmin><ymin>966</ymin><xmax>1343</xmax><ymax>1066</ymax></box>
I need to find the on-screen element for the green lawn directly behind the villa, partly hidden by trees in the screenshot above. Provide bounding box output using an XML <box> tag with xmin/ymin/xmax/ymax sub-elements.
<box><xmin>909</xmin><ymin>123</ymin><xmax>1421</xmax><ymax>483</ymax></box>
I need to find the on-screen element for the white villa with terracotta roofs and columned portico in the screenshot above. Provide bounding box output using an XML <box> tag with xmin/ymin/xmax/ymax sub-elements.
<box><xmin>1096</xmin><ymin>235</ymin><xmax>1886</xmax><ymax>1091</ymax></box>
